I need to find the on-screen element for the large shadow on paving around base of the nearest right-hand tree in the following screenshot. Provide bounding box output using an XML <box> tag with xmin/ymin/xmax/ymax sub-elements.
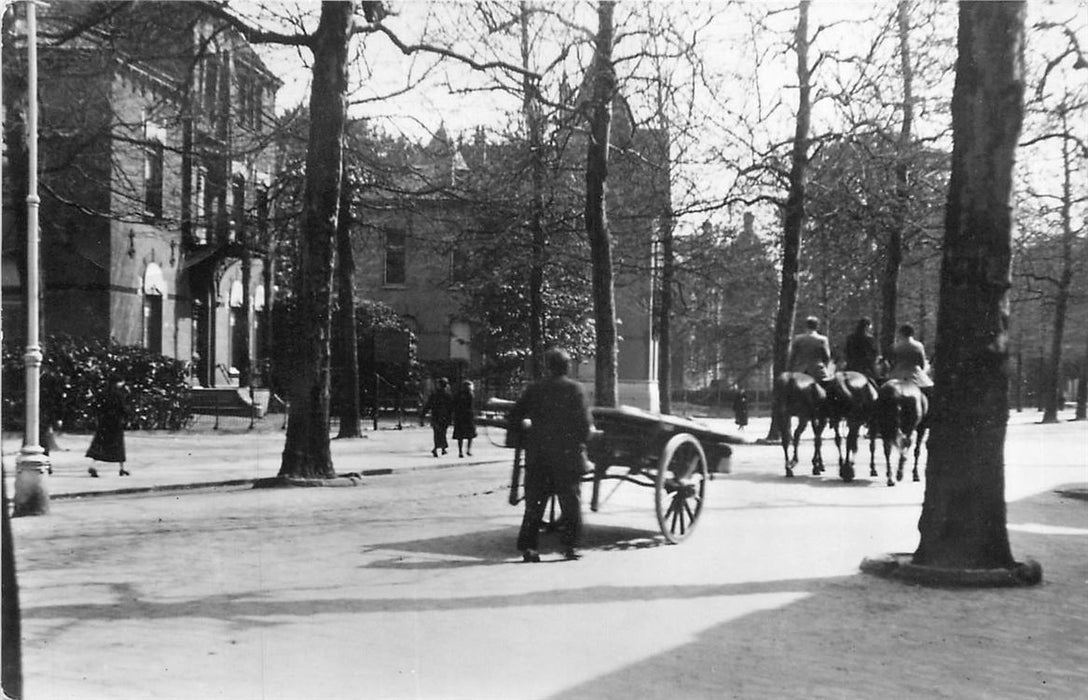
<box><xmin>552</xmin><ymin>492</ymin><xmax>1088</xmax><ymax>700</ymax></box>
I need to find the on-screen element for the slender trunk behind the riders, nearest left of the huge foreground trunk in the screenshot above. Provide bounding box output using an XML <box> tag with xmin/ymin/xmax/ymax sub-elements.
<box><xmin>880</xmin><ymin>0</ymin><xmax>914</xmax><ymax>357</ymax></box>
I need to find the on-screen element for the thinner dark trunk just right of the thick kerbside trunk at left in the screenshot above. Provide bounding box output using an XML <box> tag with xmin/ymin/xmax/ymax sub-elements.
<box><xmin>336</xmin><ymin>163</ymin><xmax>361</xmax><ymax>438</ymax></box>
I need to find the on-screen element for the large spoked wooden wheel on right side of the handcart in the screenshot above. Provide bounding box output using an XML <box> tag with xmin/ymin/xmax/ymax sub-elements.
<box><xmin>654</xmin><ymin>432</ymin><xmax>709</xmax><ymax>544</ymax></box>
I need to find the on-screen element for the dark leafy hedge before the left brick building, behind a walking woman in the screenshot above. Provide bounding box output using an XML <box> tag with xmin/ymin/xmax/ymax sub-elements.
<box><xmin>3</xmin><ymin>336</ymin><xmax>191</xmax><ymax>432</ymax></box>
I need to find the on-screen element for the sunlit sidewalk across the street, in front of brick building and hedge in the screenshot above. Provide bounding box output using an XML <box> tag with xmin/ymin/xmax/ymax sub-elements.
<box><xmin>2</xmin><ymin>416</ymin><xmax>514</xmax><ymax>499</ymax></box>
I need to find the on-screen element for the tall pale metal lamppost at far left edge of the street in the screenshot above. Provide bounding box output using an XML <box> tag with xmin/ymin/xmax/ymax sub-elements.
<box><xmin>14</xmin><ymin>0</ymin><xmax>49</xmax><ymax>516</ymax></box>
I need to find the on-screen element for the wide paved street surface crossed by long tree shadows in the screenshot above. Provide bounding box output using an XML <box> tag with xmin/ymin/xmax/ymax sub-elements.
<box><xmin>5</xmin><ymin>418</ymin><xmax>1088</xmax><ymax>700</ymax></box>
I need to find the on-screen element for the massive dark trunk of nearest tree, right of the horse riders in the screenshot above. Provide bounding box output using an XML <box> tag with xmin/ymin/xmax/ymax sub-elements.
<box><xmin>914</xmin><ymin>2</ymin><xmax>1024</xmax><ymax>569</ymax></box>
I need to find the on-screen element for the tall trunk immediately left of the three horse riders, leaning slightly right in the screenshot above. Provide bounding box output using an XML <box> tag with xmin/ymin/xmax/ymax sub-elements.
<box><xmin>767</xmin><ymin>0</ymin><xmax>812</xmax><ymax>440</ymax></box>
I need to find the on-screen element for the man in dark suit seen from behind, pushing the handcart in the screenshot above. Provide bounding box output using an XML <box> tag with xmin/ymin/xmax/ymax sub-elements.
<box><xmin>509</xmin><ymin>348</ymin><xmax>590</xmax><ymax>562</ymax></box>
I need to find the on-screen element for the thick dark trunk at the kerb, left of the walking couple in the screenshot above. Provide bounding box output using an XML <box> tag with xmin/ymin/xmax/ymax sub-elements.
<box><xmin>280</xmin><ymin>2</ymin><xmax>354</xmax><ymax>478</ymax></box>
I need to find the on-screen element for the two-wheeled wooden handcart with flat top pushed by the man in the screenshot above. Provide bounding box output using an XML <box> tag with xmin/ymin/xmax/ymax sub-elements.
<box><xmin>483</xmin><ymin>398</ymin><xmax>744</xmax><ymax>543</ymax></box>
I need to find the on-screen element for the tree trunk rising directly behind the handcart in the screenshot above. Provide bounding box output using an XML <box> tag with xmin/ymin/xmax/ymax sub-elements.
<box><xmin>585</xmin><ymin>0</ymin><xmax>619</xmax><ymax>406</ymax></box>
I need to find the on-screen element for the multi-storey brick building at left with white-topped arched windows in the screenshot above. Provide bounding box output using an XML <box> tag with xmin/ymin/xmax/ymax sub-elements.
<box><xmin>3</xmin><ymin>1</ymin><xmax>280</xmax><ymax>385</ymax></box>
